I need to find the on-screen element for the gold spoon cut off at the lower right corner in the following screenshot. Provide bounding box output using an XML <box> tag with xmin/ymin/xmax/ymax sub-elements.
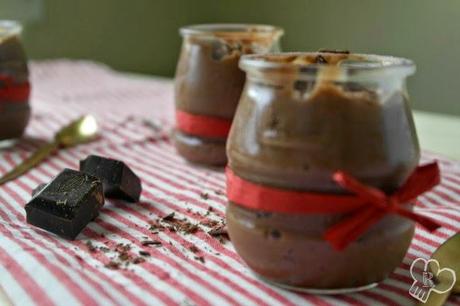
<box><xmin>418</xmin><ymin>233</ymin><xmax>460</xmax><ymax>306</ymax></box>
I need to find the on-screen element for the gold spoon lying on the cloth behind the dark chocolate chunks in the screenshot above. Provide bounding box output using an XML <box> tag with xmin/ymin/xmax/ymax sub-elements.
<box><xmin>0</xmin><ymin>115</ymin><xmax>98</xmax><ymax>185</ymax></box>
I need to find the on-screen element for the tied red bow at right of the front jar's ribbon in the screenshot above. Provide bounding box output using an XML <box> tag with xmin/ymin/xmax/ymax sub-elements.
<box><xmin>324</xmin><ymin>162</ymin><xmax>440</xmax><ymax>250</ymax></box>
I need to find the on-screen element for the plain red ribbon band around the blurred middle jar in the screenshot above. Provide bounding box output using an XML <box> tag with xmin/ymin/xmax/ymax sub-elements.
<box><xmin>176</xmin><ymin>110</ymin><xmax>232</xmax><ymax>138</ymax></box>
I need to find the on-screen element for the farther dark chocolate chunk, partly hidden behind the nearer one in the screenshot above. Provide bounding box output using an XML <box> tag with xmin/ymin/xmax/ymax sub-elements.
<box><xmin>80</xmin><ymin>155</ymin><xmax>142</xmax><ymax>202</ymax></box>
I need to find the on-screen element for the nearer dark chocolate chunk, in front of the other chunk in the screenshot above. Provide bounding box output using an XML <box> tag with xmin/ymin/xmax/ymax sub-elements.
<box><xmin>25</xmin><ymin>169</ymin><xmax>104</xmax><ymax>240</ymax></box>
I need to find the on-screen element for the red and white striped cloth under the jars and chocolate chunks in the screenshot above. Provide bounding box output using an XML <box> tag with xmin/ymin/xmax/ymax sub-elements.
<box><xmin>0</xmin><ymin>60</ymin><xmax>460</xmax><ymax>306</ymax></box>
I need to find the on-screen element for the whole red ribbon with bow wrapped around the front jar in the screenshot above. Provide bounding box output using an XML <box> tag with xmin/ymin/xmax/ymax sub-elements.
<box><xmin>226</xmin><ymin>162</ymin><xmax>440</xmax><ymax>250</ymax></box>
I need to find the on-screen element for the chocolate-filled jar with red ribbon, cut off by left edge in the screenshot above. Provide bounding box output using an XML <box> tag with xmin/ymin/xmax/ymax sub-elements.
<box><xmin>0</xmin><ymin>20</ymin><xmax>30</xmax><ymax>141</ymax></box>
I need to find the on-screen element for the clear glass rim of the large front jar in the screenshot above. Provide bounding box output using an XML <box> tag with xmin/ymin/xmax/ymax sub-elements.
<box><xmin>240</xmin><ymin>52</ymin><xmax>415</xmax><ymax>74</ymax></box>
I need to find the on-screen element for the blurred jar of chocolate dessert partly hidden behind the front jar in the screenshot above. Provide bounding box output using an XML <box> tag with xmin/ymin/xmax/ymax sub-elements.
<box><xmin>173</xmin><ymin>24</ymin><xmax>283</xmax><ymax>166</ymax></box>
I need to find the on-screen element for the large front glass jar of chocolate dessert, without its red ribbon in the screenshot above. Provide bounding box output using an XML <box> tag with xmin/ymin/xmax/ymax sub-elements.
<box><xmin>226</xmin><ymin>51</ymin><xmax>419</xmax><ymax>293</ymax></box>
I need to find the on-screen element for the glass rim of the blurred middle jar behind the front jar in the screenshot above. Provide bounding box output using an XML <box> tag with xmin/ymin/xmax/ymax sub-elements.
<box><xmin>179</xmin><ymin>23</ymin><xmax>284</xmax><ymax>37</ymax></box>
